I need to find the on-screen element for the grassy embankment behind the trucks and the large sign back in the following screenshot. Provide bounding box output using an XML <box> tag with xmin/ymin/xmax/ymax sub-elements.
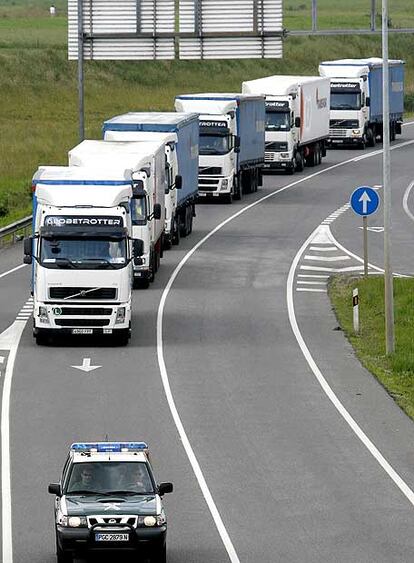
<box><xmin>0</xmin><ymin>0</ymin><xmax>414</xmax><ymax>225</ymax></box>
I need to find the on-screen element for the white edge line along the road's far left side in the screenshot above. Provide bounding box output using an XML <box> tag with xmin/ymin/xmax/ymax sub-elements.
<box><xmin>0</xmin><ymin>320</ymin><xmax>27</xmax><ymax>563</ymax></box>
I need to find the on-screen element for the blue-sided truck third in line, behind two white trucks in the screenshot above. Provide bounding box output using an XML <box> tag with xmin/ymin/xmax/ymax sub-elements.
<box><xmin>103</xmin><ymin>112</ymin><xmax>199</xmax><ymax>247</ymax></box>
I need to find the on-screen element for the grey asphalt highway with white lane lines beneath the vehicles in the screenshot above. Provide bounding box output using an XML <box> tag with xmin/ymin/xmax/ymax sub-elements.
<box><xmin>0</xmin><ymin>126</ymin><xmax>414</xmax><ymax>563</ymax></box>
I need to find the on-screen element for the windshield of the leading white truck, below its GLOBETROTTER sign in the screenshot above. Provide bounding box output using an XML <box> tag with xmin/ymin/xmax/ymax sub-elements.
<box><xmin>40</xmin><ymin>237</ymin><xmax>127</xmax><ymax>270</ymax></box>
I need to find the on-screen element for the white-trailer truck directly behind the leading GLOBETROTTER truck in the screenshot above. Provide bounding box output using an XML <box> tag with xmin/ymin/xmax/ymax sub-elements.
<box><xmin>69</xmin><ymin>140</ymin><xmax>167</xmax><ymax>288</ymax></box>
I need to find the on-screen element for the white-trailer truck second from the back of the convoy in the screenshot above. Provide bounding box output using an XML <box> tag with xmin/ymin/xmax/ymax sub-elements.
<box><xmin>242</xmin><ymin>75</ymin><xmax>330</xmax><ymax>174</ymax></box>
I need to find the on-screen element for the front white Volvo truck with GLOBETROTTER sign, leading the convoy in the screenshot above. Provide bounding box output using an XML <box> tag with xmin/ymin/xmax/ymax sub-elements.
<box><xmin>24</xmin><ymin>166</ymin><xmax>142</xmax><ymax>345</ymax></box>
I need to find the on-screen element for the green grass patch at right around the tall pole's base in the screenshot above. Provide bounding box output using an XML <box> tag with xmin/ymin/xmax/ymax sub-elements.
<box><xmin>329</xmin><ymin>276</ymin><xmax>414</xmax><ymax>424</ymax></box>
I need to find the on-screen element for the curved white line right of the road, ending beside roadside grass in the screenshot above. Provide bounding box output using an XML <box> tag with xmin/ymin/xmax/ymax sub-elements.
<box><xmin>287</xmin><ymin>227</ymin><xmax>414</xmax><ymax>505</ymax></box>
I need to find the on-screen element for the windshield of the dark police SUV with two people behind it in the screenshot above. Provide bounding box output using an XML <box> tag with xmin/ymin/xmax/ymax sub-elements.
<box><xmin>65</xmin><ymin>461</ymin><xmax>154</xmax><ymax>495</ymax></box>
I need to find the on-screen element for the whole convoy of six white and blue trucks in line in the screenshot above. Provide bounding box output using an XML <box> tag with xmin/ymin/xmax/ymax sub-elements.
<box><xmin>24</xmin><ymin>58</ymin><xmax>404</xmax><ymax>344</ymax></box>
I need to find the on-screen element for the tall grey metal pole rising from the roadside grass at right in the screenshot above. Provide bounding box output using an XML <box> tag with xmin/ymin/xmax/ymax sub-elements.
<box><xmin>382</xmin><ymin>0</ymin><xmax>395</xmax><ymax>354</ymax></box>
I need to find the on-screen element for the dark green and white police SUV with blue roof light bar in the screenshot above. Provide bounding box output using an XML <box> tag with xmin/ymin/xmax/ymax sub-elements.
<box><xmin>49</xmin><ymin>442</ymin><xmax>173</xmax><ymax>563</ymax></box>
